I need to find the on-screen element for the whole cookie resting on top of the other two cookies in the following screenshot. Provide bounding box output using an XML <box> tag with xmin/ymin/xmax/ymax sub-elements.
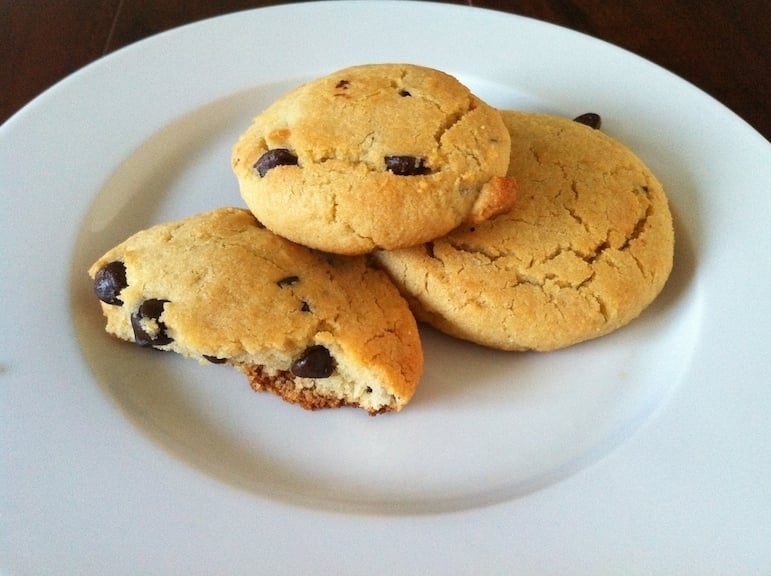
<box><xmin>231</xmin><ymin>64</ymin><xmax>516</xmax><ymax>254</ymax></box>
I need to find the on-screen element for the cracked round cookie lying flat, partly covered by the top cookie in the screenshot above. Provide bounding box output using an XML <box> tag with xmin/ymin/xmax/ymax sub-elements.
<box><xmin>376</xmin><ymin>112</ymin><xmax>674</xmax><ymax>351</ymax></box>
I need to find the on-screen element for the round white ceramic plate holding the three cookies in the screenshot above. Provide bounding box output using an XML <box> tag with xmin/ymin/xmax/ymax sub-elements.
<box><xmin>0</xmin><ymin>2</ymin><xmax>771</xmax><ymax>574</ymax></box>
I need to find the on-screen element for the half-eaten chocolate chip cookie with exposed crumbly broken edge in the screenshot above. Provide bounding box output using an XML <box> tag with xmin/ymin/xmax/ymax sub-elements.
<box><xmin>89</xmin><ymin>208</ymin><xmax>423</xmax><ymax>414</ymax></box>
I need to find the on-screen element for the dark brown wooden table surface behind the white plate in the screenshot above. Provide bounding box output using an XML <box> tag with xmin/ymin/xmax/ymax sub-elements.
<box><xmin>0</xmin><ymin>0</ymin><xmax>771</xmax><ymax>139</ymax></box>
